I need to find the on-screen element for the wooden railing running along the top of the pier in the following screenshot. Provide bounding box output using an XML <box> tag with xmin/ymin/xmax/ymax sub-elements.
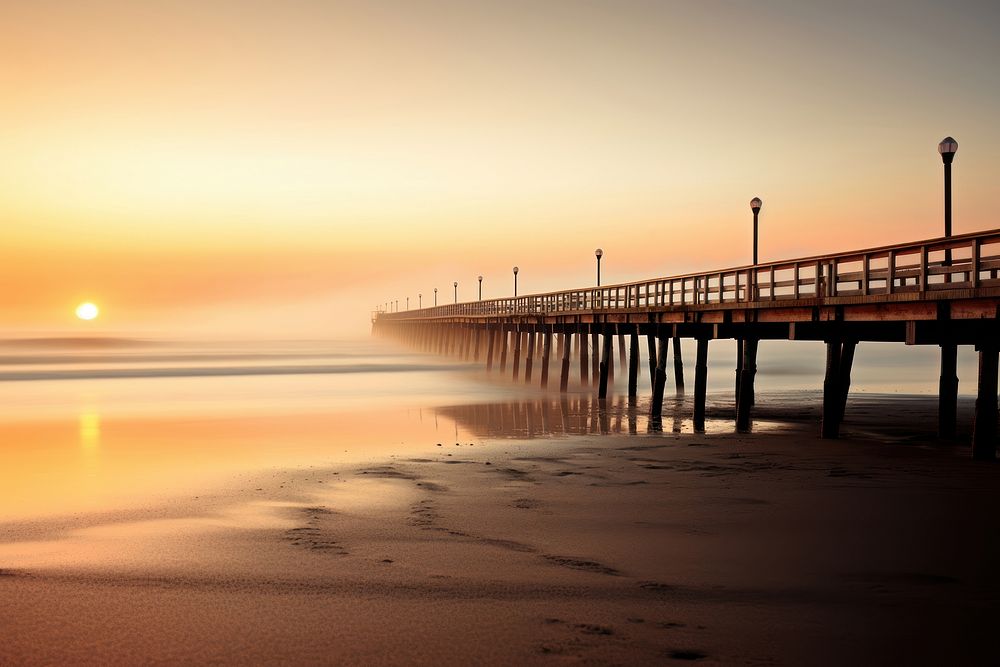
<box><xmin>378</xmin><ymin>229</ymin><xmax>1000</xmax><ymax>319</ymax></box>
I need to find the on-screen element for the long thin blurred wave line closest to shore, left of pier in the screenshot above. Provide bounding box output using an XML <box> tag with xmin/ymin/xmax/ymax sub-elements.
<box><xmin>0</xmin><ymin>364</ymin><xmax>456</xmax><ymax>382</ymax></box>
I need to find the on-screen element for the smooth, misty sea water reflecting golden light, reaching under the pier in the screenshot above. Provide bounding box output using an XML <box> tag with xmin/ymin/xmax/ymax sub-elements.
<box><xmin>0</xmin><ymin>338</ymin><xmax>975</xmax><ymax>521</ymax></box>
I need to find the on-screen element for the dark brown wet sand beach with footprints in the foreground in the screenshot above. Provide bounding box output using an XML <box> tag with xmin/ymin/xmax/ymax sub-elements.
<box><xmin>0</xmin><ymin>400</ymin><xmax>1000</xmax><ymax>665</ymax></box>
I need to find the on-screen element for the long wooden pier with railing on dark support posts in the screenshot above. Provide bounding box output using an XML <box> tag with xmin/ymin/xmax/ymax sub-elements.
<box><xmin>372</xmin><ymin>229</ymin><xmax>1000</xmax><ymax>460</ymax></box>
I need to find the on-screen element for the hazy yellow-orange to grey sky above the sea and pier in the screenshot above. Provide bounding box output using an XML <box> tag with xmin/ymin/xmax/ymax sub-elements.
<box><xmin>0</xmin><ymin>0</ymin><xmax>1000</xmax><ymax>338</ymax></box>
